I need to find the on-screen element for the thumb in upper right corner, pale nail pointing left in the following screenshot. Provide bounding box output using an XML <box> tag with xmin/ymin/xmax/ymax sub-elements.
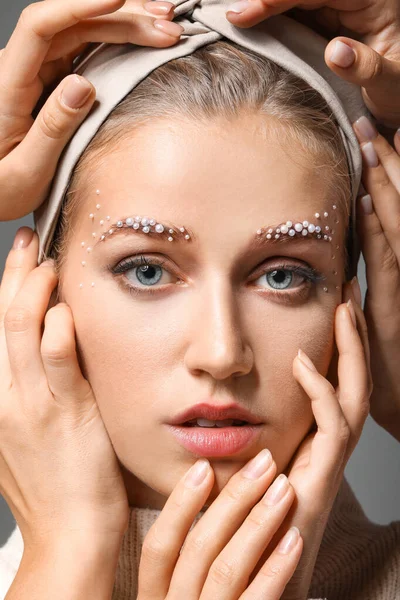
<box><xmin>325</xmin><ymin>37</ymin><xmax>400</xmax><ymax>127</ymax></box>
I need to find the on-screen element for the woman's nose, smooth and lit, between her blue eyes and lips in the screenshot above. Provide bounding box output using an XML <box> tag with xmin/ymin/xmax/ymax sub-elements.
<box><xmin>185</xmin><ymin>282</ymin><xmax>253</xmax><ymax>379</ymax></box>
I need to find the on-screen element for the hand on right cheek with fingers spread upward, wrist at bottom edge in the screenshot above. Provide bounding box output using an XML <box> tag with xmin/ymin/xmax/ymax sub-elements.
<box><xmin>253</xmin><ymin>296</ymin><xmax>372</xmax><ymax>600</ymax></box>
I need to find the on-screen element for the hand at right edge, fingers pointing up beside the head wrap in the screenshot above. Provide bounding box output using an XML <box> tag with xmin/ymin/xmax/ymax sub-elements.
<box><xmin>344</xmin><ymin>117</ymin><xmax>400</xmax><ymax>442</ymax></box>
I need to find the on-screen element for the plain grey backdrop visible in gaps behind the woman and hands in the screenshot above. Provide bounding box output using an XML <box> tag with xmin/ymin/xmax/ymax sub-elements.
<box><xmin>0</xmin><ymin>0</ymin><xmax>400</xmax><ymax>545</ymax></box>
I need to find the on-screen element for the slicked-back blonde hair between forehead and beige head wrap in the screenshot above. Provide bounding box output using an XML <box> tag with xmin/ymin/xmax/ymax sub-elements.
<box><xmin>49</xmin><ymin>40</ymin><xmax>351</xmax><ymax>277</ymax></box>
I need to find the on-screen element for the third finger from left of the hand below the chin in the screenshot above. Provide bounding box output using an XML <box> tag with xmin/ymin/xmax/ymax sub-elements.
<box><xmin>200</xmin><ymin>474</ymin><xmax>297</xmax><ymax>600</ymax></box>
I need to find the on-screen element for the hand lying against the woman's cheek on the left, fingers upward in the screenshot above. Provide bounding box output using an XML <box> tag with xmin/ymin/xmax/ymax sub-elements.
<box><xmin>0</xmin><ymin>228</ymin><xmax>129</xmax><ymax>549</ymax></box>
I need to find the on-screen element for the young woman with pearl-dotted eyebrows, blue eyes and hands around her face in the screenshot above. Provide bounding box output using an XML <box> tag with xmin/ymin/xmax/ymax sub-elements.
<box><xmin>0</xmin><ymin>1</ymin><xmax>400</xmax><ymax>600</ymax></box>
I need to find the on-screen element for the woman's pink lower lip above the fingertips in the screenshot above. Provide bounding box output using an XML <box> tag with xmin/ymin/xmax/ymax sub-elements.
<box><xmin>167</xmin><ymin>424</ymin><xmax>262</xmax><ymax>457</ymax></box>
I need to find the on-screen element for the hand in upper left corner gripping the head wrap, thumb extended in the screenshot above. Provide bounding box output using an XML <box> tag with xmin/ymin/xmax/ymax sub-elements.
<box><xmin>0</xmin><ymin>0</ymin><xmax>183</xmax><ymax>221</ymax></box>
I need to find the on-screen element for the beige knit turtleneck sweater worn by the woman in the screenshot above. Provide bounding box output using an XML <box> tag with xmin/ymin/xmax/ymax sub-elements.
<box><xmin>0</xmin><ymin>478</ymin><xmax>400</xmax><ymax>600</ymax></box>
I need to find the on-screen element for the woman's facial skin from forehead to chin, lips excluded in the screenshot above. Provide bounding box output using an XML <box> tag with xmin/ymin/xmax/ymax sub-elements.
<box><xmin>60</xmin><ymin>116</ymin><xmax>345</xmax><ymax>508</ymax></box>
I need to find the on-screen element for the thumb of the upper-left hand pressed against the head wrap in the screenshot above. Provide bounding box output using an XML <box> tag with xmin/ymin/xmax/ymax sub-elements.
<box><xmin>0</xmin><ymin>75</ymin><xmax>95</xmax><ymax>218</ymax></box>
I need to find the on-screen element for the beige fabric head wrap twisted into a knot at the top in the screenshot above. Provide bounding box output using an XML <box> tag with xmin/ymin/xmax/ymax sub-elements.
<box><xmin>34</xmin><ymin>0</ymin><xmax>369</xmax><ymax>277</ymax></box>
